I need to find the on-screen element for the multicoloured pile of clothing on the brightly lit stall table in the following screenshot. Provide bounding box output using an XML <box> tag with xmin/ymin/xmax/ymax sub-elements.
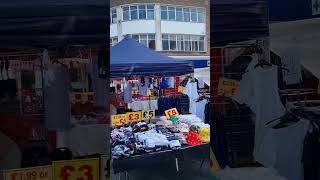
<box><xmin>111</xmin><ymin>115</ymin><xmax>210</xmax><ymax>159</ymax></box>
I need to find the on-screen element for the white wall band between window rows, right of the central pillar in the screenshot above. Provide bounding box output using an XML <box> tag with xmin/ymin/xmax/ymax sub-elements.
<box><xmin>161</xmin><ymin>21</ymin><xmax>206</xmax><ymax>35</ymax></box>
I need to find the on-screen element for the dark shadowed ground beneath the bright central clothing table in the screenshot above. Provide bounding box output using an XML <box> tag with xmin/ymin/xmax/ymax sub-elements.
<box><xmin>111</xmin><ymin>161</ymin><xmax>210</xmax><ymax>180</ymax></box>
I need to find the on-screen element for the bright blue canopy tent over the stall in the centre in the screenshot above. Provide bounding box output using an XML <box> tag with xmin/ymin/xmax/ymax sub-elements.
<box><xmin>110</xmin><ymin>37</ymin><xmax>193</xmax><ymax>77</ymax></box>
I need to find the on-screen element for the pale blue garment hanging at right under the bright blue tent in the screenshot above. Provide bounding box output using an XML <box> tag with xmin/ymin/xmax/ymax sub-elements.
<box><xmin>183</xmin><ymin>82</ymin><xmax>199</xmax><ymax>114</ymax></box>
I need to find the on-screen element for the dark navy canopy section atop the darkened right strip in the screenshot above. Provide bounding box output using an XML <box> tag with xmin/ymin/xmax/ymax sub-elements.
<box><xmin>210</xmin><ymin>0</ymin><xmax>269</xmax><ymax>46</ymax></box>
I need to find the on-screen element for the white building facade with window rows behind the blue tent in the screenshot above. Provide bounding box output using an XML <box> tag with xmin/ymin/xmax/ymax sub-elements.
<box><xmin>110</xmin><ymin>0</ymin><xmax>210</xmax><ymax>67</ymax></box>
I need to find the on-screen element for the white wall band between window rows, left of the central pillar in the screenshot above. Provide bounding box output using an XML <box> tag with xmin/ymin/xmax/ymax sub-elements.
<box><xmin>122</xmin><ymin>20</ymin><xmax>156</xmax><ymax>35</ymax></box>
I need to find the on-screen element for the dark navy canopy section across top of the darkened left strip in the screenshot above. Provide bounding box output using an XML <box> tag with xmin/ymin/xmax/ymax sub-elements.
<box><xmin>0</xmin><ymin>0</ymin><xmax>109</xmax><ymax>48</ymax></box>
